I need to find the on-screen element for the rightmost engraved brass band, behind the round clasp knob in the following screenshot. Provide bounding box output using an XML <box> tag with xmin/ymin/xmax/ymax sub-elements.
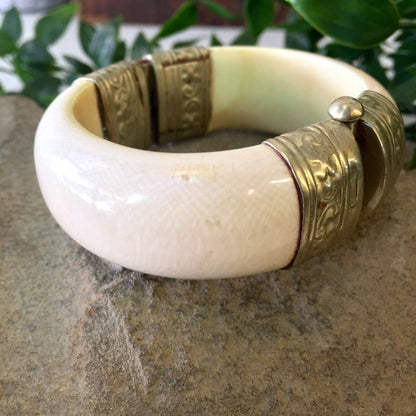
<box><xmin>354</xmin><ymin>91</ymin><xmax>406</xmax><ymax>212</ymax></box>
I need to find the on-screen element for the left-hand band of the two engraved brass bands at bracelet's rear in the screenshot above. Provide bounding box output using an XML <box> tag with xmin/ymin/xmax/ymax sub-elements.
<box><xmin>82</xmin><ymin>61</ymin><xmax>153</xmax><ymax>148</ymax></box>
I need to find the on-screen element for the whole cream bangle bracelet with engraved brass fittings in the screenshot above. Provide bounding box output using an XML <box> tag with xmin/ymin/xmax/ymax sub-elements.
<box><xmin>35</xmin><ymin>47</ymin><xmax>404</xmax><ymax>279</ymax></box>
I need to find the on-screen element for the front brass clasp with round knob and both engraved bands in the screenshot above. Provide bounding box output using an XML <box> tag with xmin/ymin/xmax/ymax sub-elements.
<box><xmin>264</xmin><ymin>91</ymin><xmax>405</xmax><ymax>266</ymax></box>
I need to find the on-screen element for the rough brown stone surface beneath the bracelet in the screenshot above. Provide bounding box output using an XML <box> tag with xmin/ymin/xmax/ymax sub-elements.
<box><xmin>0</xmin><ymin>97</ymin><xmax>416</xmax><ymax>416</ymax></box>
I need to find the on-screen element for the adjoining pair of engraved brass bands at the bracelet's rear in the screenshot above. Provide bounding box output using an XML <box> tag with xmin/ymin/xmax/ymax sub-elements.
<box><xmin>81</xmin><ymin>47</ymin><xmax>211</xmax><ymax>148</ymax></box>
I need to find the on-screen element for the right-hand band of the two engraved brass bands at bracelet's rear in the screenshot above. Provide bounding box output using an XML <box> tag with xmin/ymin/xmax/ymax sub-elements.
<box><xmin>145</xmin><ymin>47</ymin><xmax>211</xmax><ymax>143</ymax></box>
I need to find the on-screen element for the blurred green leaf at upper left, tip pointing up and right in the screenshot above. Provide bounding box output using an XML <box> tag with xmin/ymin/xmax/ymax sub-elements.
<box><xmin>35</xmin><ymin>3</ymin><xmax>79</xmax><ymax>46</ymax></box>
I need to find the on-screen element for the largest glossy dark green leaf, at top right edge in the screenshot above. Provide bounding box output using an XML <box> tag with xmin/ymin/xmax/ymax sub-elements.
<box><xmin>288</xmin><ymin>0</ymin><xmax>399</xmax><ymax>49</ymax></box>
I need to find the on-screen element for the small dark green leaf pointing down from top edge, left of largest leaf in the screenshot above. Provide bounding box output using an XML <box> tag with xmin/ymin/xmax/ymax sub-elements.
<box><xmin>244</xmin><ymin>0</ymin><xmax>274</xmax><ymax>39</ymax></box>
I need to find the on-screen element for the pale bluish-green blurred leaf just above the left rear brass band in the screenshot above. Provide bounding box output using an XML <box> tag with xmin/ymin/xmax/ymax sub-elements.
<box><xmin>85</xmin><ymin>17</ymin><xmax>121</xmax><ymax>68</ymax></box>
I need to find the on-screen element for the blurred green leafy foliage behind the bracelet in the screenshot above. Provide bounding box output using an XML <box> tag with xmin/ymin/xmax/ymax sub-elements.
<box><xmin>0</xmin><ymin>0</ymin><xmax>416</xmax><ymax>168</ymax></box>
